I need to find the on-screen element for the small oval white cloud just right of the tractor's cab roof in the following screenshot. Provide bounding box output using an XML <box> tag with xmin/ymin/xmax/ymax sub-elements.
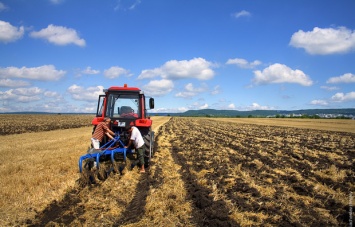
<box><xmin>142</xmin><ymin>79</ymin><xmax>174</xmax><ymax>96</ymax></box>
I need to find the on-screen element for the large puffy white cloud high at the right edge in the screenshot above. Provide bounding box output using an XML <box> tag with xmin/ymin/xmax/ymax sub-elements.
<box><xmin>290</xmin><ymin>27</ymin><xmax>355</xmax><ymax>55</ymax></box>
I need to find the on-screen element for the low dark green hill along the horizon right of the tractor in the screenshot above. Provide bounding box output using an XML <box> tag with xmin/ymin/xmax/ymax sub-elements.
<box><xmin>152</xmin><ymin>108</ymin><xmax>355</xmax><ymax>117</ymax></box>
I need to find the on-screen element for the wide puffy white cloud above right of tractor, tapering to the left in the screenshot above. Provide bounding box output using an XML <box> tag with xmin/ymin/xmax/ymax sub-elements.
<box><xmin>138</xmin><ymin>58</ymin><xmax>214</xmax><ymax>80</ymax></box>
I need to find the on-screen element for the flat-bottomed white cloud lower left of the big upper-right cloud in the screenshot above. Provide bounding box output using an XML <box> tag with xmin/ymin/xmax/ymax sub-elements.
<box><xmin>253</xmin><ymin>63</ymin><xmax>313</xmax><ymax>86</ymax></box>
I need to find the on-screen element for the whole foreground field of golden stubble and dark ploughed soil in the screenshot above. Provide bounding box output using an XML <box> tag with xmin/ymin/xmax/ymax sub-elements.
<box><xmin>0</xmin><ymin>117</ymin><xmax>355</xmax><ymax>226</ymax></box>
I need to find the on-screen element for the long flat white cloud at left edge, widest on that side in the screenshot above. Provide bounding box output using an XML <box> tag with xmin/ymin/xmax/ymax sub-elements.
<box><xmin>0</xmin><ymin>65</ymin><xmax>66</xmax><ymax>81</ymax></box>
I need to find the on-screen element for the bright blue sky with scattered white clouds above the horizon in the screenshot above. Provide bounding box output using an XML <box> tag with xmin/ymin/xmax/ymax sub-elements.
<box><xmin>0</xmin><ymin>0</ymin><xmax>355</xmax><ymax>113</ymax></box>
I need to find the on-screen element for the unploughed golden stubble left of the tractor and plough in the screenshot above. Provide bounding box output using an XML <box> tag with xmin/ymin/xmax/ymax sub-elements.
<box><xmin>0</xmin><ymin>127</ymin><xmax>91</xmax><ymax>226</ymax></box>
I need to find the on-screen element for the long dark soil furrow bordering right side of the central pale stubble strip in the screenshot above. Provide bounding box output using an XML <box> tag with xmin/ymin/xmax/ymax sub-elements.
<box><xmin>164</xmin><ymin>120</ymin><xmax>240</xmax><ymax>227</ymax></box>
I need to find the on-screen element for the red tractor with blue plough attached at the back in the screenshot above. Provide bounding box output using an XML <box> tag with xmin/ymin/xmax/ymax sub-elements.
<box><xmin>79</xmin><ymin>84</ymin><xmax>154</xmax><ymax>181</ymax></box>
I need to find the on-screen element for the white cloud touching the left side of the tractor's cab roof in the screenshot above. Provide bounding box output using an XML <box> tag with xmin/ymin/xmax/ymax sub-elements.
<box><xmin>67</xmin><ymin>84</ymin><xmax>104</xmax><ymax>102</ymax></box>
